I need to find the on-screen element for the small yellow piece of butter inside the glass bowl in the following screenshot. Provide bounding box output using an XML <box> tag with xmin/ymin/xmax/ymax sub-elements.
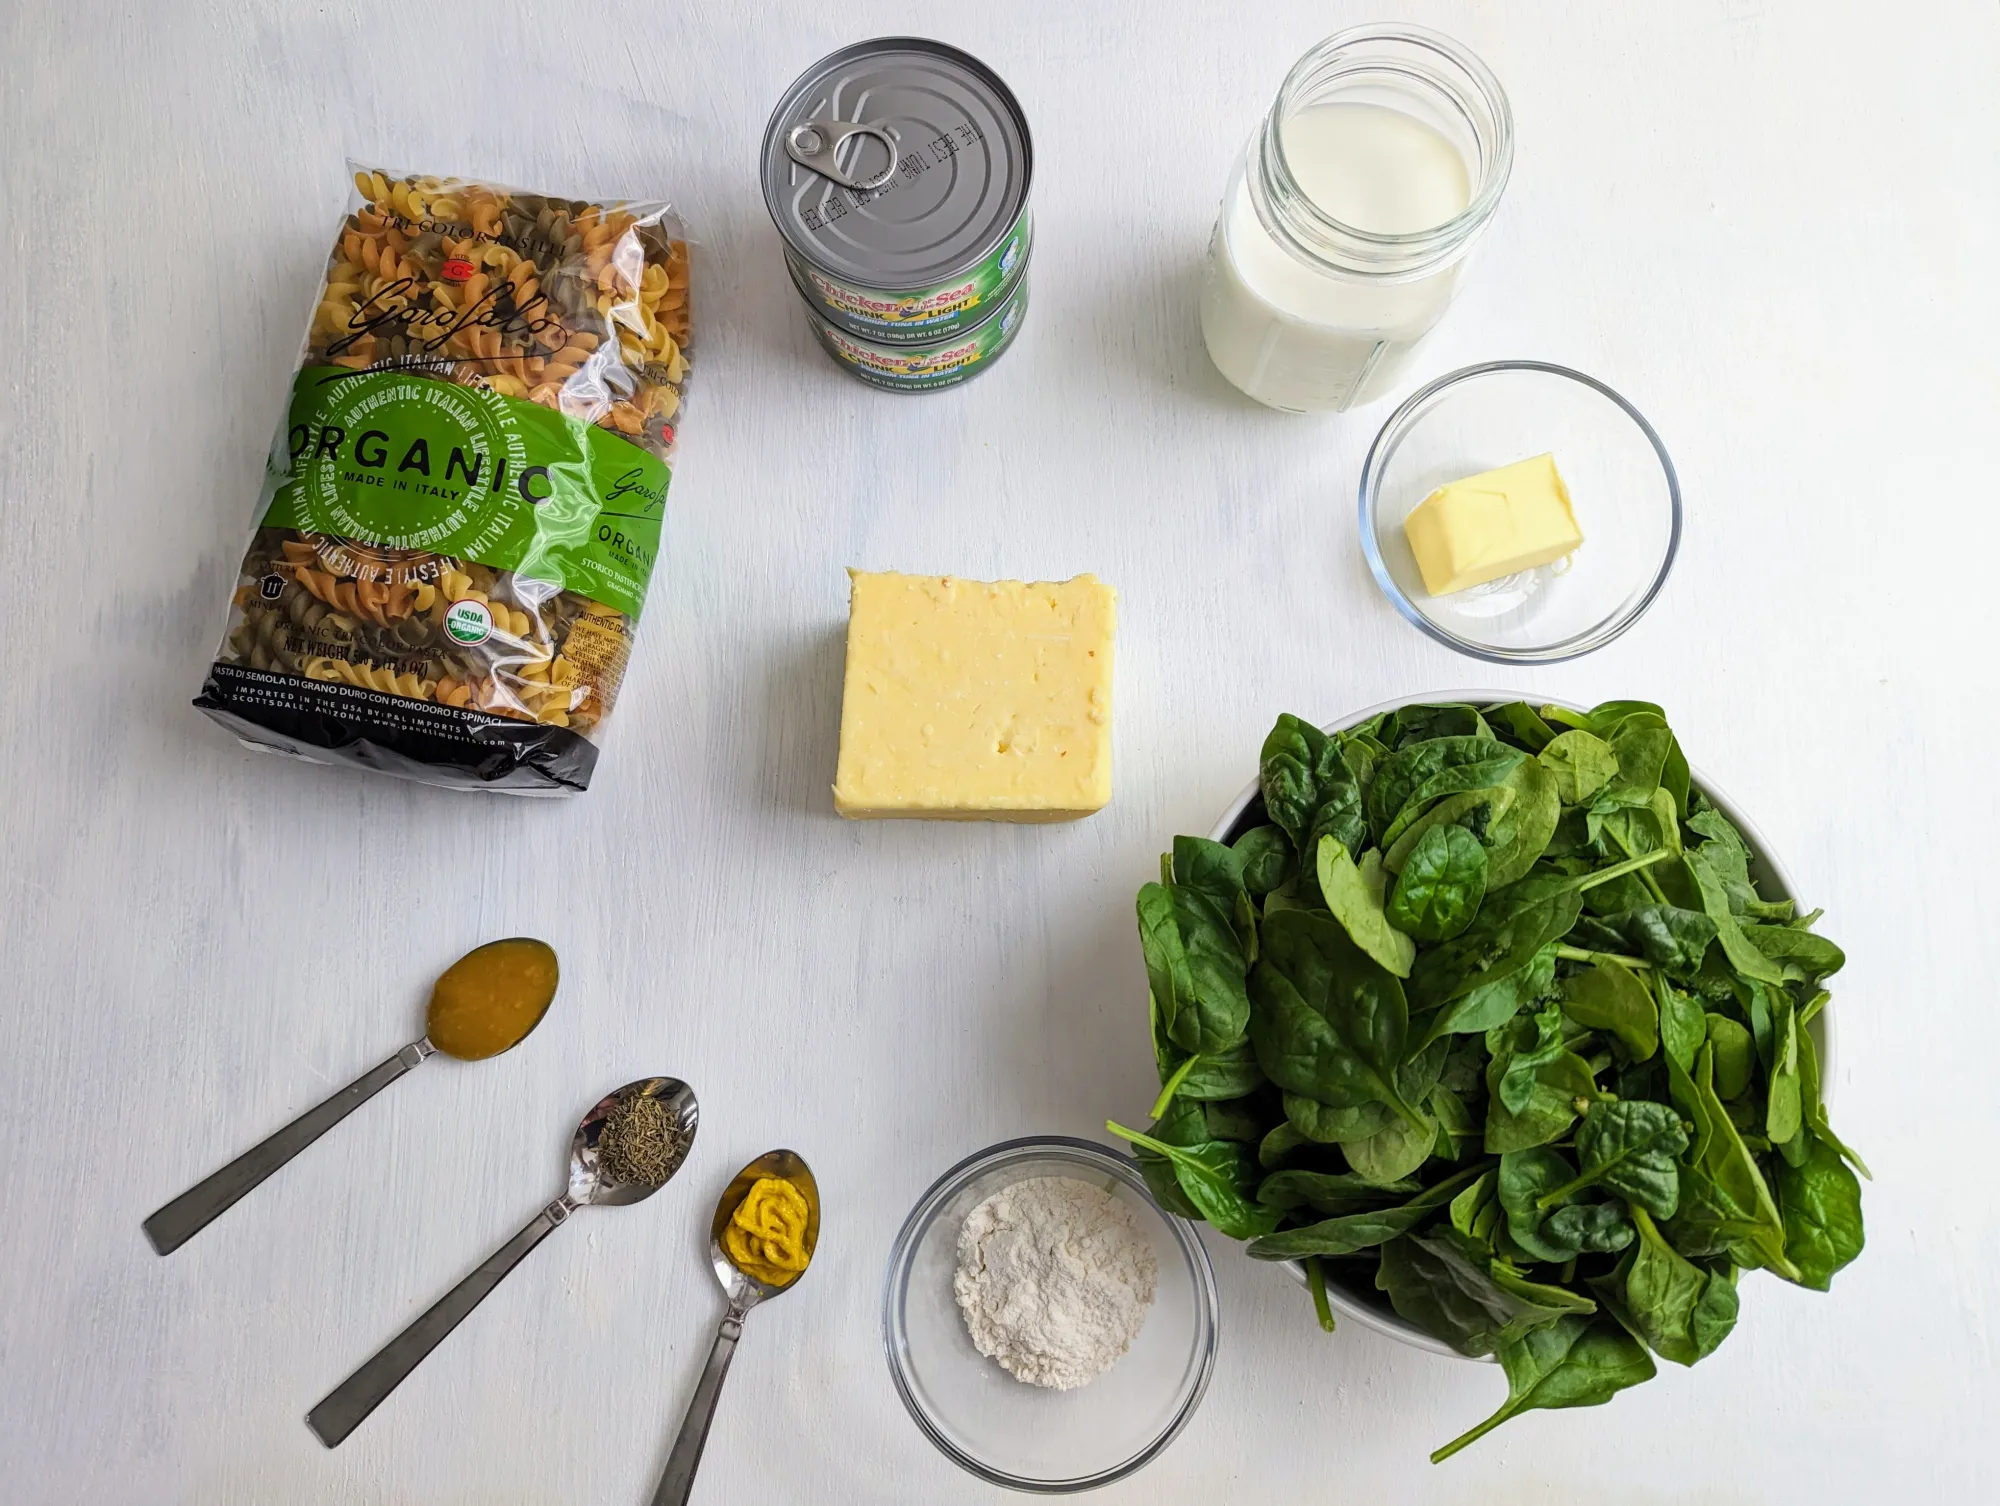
<box><xmin>1402</xmin><ymin>454</ymin><xmax>1584</xmax><ymax>596</ymax></box>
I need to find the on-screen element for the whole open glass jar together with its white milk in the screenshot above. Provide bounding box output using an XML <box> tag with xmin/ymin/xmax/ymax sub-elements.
<box><xmin>1202</xmin><ymin>26</ymin><xmax>1514</xmax><ymax>412</ymax></box>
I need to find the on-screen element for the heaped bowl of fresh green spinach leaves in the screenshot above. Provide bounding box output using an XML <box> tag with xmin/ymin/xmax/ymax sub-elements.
<box><xmin>1108</xmin><ymin>696</ymin><xmax>1868</xmax><ymax>1460</ymax></box>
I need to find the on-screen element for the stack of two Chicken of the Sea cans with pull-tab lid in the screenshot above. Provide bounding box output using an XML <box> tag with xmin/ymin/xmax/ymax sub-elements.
<box><xmin>762</xmin><ymin>36</ymin><xmax>1034</xmax><ymax>392</ymax></box>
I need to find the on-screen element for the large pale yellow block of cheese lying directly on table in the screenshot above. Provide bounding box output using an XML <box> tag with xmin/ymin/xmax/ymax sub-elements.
<box><xmin>834</xmin><ymin>570</ymin><xmax>1118</xmax><ymax>822</ymax></box>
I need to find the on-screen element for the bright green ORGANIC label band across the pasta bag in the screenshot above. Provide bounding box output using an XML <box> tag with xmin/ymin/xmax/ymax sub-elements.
<box><xmin>264</xmin><ymin>366</ymin><xmax>672</xmax><ymax>618</ymax></box>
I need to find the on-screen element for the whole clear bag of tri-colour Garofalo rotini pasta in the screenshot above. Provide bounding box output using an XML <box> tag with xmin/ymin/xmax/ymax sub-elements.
<box><xmin>194</xmin><ymin>170</ymin><xmax>688</xmax><ymax>794</ymax></box>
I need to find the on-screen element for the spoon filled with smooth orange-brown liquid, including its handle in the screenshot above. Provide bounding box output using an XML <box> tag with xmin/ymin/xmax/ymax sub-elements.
<box><xmin>144</xmin><ymin>936</ymin><xmax>556</xmax><ymax>1254</ymax></box>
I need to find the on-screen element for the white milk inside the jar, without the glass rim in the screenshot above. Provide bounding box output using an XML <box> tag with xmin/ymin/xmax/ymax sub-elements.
<box><xmin>1202</xmin><ymin>102</ymin><xmax>1472</xmax><ymax>412</ymax></box>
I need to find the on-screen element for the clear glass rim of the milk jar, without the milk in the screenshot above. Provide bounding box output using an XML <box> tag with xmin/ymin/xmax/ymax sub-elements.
<box><xmin>1262</xmin><ymin>22</ymin><xmax>1514</xmax><ymax>276</ymax></box>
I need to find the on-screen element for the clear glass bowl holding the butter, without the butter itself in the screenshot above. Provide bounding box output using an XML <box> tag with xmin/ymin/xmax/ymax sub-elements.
<box><xmin>1360</xmin><ymin>360</ymin><xmax>1680</xmax><ymax>664</ymax></box>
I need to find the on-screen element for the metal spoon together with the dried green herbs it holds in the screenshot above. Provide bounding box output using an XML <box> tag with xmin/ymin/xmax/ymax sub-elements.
<box><xmin>306</xmin><ymin>1078</ymin><xmax>696</xmax><ymax>1448</ymax></box>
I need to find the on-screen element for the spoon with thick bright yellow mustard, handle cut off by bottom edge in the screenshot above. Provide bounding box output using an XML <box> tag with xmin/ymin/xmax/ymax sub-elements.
<box><xmin>652</xmin><ymin>1150</ymin><xmax>820</xmax><ymax>1506</ymax></box>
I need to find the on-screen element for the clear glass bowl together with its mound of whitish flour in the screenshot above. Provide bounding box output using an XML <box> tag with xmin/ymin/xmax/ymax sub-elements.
<box><xmin>882</xmin><ymin>1136</ymin><xmax>1216</xmax><ymax>1494</ymax></box>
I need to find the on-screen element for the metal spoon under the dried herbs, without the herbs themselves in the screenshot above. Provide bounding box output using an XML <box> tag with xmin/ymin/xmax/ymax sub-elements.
<box><xmin>306</xmin><ymin>1078</ymin><xmax>696</xmax><ymax>1448</ymax></box>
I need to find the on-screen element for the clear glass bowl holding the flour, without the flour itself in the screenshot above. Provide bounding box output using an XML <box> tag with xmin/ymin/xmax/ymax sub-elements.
<box><xmin>882</xmin><ymin>1136</ymin><xmax>1218</xmax><ymax>1496</ymax></box>
